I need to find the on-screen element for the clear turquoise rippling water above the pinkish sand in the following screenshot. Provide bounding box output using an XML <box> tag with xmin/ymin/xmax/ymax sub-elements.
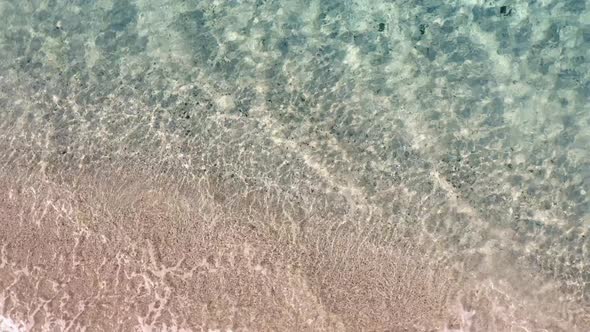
<box><xmin>0</xmin><ymin>0</ymin><xmax>590</xmax><ymax>331</ymax></box>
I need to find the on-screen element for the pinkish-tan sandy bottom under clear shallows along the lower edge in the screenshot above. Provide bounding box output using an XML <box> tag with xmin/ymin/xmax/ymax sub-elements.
<box><xmin>0</xmin><ymin>161</ymin><xmax>589</xmax><ymax>331</ymax></box>
